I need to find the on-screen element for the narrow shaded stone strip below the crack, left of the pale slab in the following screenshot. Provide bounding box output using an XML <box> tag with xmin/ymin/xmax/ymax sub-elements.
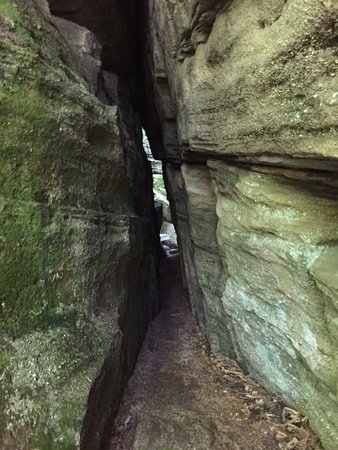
<box><xmin>178</xmin><ymin>164</ymin><xmax>233</xmax><ymax>356</ymax></box>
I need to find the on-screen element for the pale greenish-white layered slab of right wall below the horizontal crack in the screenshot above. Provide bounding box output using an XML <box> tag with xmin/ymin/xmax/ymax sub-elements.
<box><xmin>209</xmin><ymin>162</ymin><xmax>338</xmax><ymax>448</ymax></box>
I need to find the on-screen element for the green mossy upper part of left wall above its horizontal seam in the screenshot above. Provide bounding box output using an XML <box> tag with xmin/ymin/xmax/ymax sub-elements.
<box><xmin>0</xmin><ymin>5</ymin><xmax>110</xmax><ymax>203</ymax></box>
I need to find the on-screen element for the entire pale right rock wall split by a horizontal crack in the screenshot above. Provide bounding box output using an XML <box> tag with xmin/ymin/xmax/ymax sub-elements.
<box><xmin>145</xmin><ymin>0</ymin><xmax>338</xmax><ymax>450</ymax></box>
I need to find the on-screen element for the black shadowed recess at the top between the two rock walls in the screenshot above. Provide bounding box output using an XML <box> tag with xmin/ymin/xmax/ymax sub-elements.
<box><xmin>49</xmin><ymin>0</ymin><xmax>145</xmax><ymax>111</ymax></box>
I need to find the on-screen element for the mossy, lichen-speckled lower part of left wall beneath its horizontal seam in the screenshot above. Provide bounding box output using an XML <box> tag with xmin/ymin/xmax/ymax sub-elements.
<box><xmin>0</xmin><ymin>202</ymin><xmax>121</xmax><ymax>450</ymax></box>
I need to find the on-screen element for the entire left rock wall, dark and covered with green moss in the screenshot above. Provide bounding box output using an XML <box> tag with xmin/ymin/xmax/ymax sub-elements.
<box><xmin>0</xmin><ymin>0</ymin><xmax>157</xmax><ymax>450</ymax></box>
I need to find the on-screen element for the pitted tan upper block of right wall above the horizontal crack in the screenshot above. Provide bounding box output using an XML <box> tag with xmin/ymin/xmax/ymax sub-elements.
<box><xmin>145</xmin><ymin>0</ymin><xmax>338</xmax><ymax>166</ymax></box>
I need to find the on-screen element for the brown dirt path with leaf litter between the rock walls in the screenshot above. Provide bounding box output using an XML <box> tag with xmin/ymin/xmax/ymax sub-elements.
<box><xmin>105</xmin><ymin>259</ymin><xmax>321</xmax><ymax>450</ymax></box>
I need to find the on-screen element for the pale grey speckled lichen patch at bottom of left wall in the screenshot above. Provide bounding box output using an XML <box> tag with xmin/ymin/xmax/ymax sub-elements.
<box><xmin>0</xmin><ymin>316</ymin><xmax>116</xmax><ymax>450</ymax></box>
